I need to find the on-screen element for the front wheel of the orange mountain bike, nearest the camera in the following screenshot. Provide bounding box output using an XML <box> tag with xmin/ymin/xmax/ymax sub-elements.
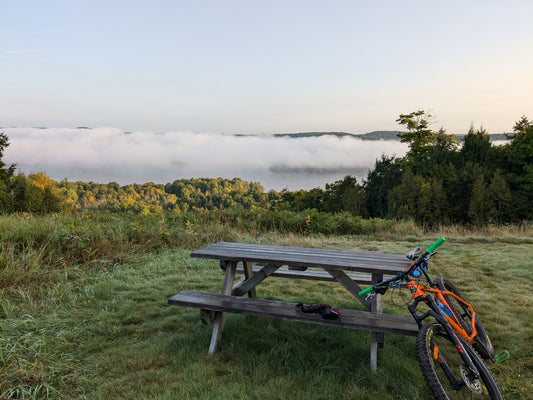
<box><xmin>416</xmin><ymin>323</ymin><xmax>503</xmax><ymax>400</ymax></box>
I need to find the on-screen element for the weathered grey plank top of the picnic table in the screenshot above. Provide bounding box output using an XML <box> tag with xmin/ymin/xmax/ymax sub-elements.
<box><xmin>191</xmin><ymin>242</ymin><xmax>411</xmax><ymax>275</ymax></box>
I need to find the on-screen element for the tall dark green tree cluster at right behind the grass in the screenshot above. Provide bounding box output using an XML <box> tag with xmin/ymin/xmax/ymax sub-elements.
<box><xmin>285</xmin><ymin>111</ymin><xmax>533</xmax><ymax>226</ymax></box>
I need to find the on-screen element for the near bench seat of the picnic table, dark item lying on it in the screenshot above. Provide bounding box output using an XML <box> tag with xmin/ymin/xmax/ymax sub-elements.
<box><xmin>168</xmin><ymin>291</ymin><xmax>418</xmax><ymax>336</ymax></box>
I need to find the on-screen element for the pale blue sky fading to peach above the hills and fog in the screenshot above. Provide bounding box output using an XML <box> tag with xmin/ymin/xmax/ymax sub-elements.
<box><xmin>0</xmin><ymin>0</ymin><xmax>533</xmax><ymax>133</ymax></box>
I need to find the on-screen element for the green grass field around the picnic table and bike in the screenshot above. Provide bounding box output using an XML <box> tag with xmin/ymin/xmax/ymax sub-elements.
<box><xmin>0</xmin><ymin>215</ymin><xmax>533</xmax><ymax>400</ymax></box>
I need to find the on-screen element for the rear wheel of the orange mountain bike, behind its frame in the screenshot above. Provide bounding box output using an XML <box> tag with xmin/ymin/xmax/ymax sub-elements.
<box><xmin>434</xmin><ymin>276</ymin><xmax>495</xmax><ymax>360</ymax></box>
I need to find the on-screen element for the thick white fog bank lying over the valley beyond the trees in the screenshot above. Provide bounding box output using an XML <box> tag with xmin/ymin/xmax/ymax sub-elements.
<box><xmin>3</xmin><ymin>128</ymin><xmax>407</xmax><ymax>190</ymax></box>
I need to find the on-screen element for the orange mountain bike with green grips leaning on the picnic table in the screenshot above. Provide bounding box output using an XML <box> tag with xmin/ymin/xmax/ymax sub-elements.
<box><xmin>359</xmin><ymin>238</ymin><xmax>502</xmax><ymax>400</ymax></box>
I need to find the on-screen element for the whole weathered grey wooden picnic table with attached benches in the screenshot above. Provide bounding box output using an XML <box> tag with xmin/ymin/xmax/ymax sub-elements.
<box><xmin>168</xmin><ymin>242</ymin><xmax>418</xmax><ymax>371</ymax></box>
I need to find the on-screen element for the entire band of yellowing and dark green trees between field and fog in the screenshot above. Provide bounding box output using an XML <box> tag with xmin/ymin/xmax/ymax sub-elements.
<box><xmin>0</xmin><ymin>111</ymin><xmax>533</xmax><ymax>226</ymax></box>
